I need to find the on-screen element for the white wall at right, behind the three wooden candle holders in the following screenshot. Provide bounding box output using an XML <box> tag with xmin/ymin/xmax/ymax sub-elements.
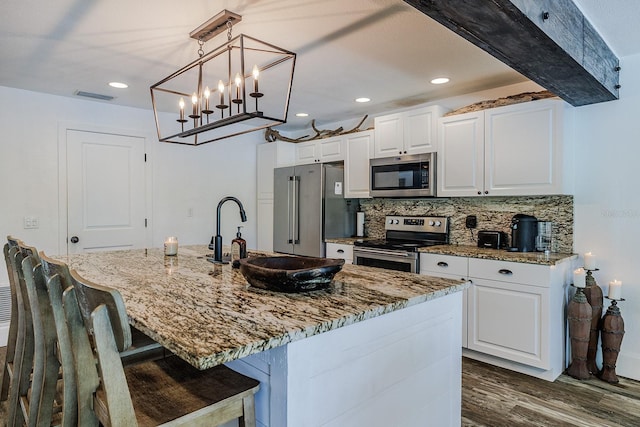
<box><xmin>574</xmin><ymin>55</ymin><xmax>640</xmax><ymax>380</ymax></box>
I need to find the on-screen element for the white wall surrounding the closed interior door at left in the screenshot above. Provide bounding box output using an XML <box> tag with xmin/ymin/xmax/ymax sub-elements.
<box><xmin>0</xmin><ymin>86</ymin><xmax>264</xmax><ymax>286</ymax></box>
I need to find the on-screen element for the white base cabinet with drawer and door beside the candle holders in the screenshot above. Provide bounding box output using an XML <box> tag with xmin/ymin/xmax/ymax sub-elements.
<box><xmin>467</xmin><ymin>258</ymin><xmax>569</xmax><ymax>381</ymax></box>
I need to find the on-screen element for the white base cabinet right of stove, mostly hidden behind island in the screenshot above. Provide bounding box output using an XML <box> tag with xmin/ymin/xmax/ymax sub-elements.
<box><xmin>420</xmin><ymin>253</ymin><xmax>469</xmax><ymax>348</ymax></box>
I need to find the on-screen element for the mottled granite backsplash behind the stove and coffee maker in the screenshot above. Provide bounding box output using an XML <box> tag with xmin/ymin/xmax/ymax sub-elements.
<box><xmin>360</xmin><ymin>196</ymin><xmax>573</xmax><ymax>253</ymax></box>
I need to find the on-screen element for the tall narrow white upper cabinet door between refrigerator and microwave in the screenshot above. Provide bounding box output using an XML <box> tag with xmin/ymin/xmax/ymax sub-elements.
<box><xmin>344</xmin><ymin>131</ymin><xmax>373</xmax><ymax>199</ymax></box>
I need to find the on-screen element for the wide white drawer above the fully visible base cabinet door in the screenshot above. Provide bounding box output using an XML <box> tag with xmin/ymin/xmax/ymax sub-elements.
<box><xmin>469</xmin><ymin>258</ymin><xmax>553</xmax><ymax>288</ymax></box>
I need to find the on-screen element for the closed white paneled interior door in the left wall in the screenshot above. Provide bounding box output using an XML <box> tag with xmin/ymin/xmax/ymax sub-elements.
<box><xmin>67</xmin><ymin>130</ymin><xmax>145</xmax><ymax>253</ymax></box>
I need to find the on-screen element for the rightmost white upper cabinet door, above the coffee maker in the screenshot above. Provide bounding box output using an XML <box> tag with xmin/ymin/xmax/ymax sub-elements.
<box><xmin>484</xmin><ymin>100</ymin><xmax>562</xmax><ymax>196</ymax></box>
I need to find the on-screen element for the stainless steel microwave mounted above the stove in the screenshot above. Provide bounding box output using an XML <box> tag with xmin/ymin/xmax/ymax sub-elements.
<box><xmin>369</xmin><ymin>153</ymin><xmax>436</xmax><ymax>197</ymax></box>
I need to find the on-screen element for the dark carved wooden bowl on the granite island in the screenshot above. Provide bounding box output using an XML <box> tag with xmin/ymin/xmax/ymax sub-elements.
<box><xmin>240</xmin><ymin>256</ymin><xmax>344</xmax><ymax>292</ymax></box>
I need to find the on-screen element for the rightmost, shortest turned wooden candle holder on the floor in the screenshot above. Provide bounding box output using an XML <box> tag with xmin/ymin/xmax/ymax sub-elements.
<box><xmin>598</xmin><ymin>298</ymin><xmax>624</xmax><ymax>384</ymax></box>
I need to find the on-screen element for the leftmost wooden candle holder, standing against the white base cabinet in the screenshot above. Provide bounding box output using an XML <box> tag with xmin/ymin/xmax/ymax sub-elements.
<box><xmin>567</xmin><ymin>288</ymin><xmax>592</xmax><ymax>380</ymax></box>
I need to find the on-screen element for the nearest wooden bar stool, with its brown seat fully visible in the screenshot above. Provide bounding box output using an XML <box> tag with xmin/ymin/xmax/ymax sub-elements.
<box><xmin>59</xmin><ymin>271</ymin><xmax>259</xmax><ymax>427</ymax></box>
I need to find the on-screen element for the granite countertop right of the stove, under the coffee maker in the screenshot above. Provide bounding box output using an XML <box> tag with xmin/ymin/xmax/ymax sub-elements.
<box><xmin>419</xmin><ymin>245</ymin><xmax>578</xmax><ymax>265</ymax></box>
